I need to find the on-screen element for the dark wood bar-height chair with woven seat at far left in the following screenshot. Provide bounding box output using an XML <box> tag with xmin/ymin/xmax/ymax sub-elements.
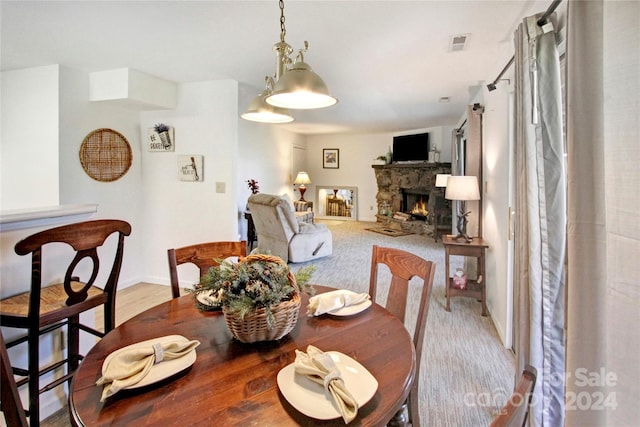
<box><xmin>0</xmin><ymin>219</ymin><xmax>131</xmax><ymax>427</ymax></box>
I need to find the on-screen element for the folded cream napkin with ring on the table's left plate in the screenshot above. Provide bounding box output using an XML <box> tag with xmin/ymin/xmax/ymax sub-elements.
<box><xmin>96</xmin><ymin>336</ymin><xmax>200</xmax><ymax>402</ymax></box>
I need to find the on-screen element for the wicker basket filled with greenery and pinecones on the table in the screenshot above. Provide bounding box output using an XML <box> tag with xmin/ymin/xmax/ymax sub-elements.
<box><xmin>194</xmin><ymin>254</ymin><xmax>315</xmax><ymax>343</ymax></box>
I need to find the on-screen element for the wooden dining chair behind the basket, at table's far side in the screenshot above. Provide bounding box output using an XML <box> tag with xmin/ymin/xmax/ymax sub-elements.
<box><xmin>167</xmin><ymin>240</ymin><xmax>247</xmax><ymax>298</ymax></box>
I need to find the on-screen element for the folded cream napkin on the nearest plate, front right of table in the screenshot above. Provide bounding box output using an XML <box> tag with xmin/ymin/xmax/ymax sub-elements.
<box><xmin>294</xmin><ymin>345</ymin><xmax>358</xmax><ymax>424</ymax></box>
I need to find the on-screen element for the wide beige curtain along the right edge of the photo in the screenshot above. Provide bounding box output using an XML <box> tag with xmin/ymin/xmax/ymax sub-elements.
<box><xmin>566</xmin><ymin>0</ymin><xmax>640</xmax><ymax>426</ymax></box>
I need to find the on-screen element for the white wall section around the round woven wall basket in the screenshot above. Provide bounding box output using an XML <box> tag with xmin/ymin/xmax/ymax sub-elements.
<box><xmin>57</xmin><ymin>67</ymin><xmax>145</xmax><ymax>289</ymax></box>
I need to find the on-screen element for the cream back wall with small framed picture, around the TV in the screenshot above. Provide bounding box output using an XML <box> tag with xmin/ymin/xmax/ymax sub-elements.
<box><xmin>305</xmin><ymin>126</ymin><xmax>453</xmax><ymax>221</ymax></box>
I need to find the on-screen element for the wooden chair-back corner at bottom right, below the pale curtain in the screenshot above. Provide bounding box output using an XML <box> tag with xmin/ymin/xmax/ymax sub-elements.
<box><xmin>490</xmin><ymin>365</ymin><xmax>538</xmax><ymax>427</ymax></box>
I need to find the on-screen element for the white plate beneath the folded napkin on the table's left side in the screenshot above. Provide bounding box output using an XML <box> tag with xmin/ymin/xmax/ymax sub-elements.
<box><xmin>102</xmin><ymin>335</ymin><xmax>196</xmax><ymax>389</ymax></box>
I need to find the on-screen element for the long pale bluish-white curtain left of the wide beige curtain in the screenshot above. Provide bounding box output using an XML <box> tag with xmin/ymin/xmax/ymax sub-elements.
<box><xmin>514</xmin><ymin>11</ymin><xmax>566</xmax><ymax>426</ymax></box>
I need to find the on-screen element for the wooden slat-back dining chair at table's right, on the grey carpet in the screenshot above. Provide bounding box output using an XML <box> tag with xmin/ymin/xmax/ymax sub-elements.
<box><xmin>369</xmin><ymin>245</ymin><xmax>436</xmax><ymax>427</ymax></box>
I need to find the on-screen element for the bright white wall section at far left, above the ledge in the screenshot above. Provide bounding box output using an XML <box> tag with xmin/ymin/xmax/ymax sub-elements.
<box><xmin>0</xmin><ymin>65</ymin><xmax>59</xmax><ymax>210</ymax></box>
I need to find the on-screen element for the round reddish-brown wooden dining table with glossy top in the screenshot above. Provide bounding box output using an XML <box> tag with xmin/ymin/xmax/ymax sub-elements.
<box><xmin>69</xmin><ymin>285</ymin><xmax>416</xmax><ymax>427</ymax></box>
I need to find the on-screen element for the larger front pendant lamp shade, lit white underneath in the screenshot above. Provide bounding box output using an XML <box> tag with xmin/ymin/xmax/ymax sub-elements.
<box><xmin>266</xmin><ymin>62</ymin><xmax>338</xmax><ymax>110</ymax></box>
